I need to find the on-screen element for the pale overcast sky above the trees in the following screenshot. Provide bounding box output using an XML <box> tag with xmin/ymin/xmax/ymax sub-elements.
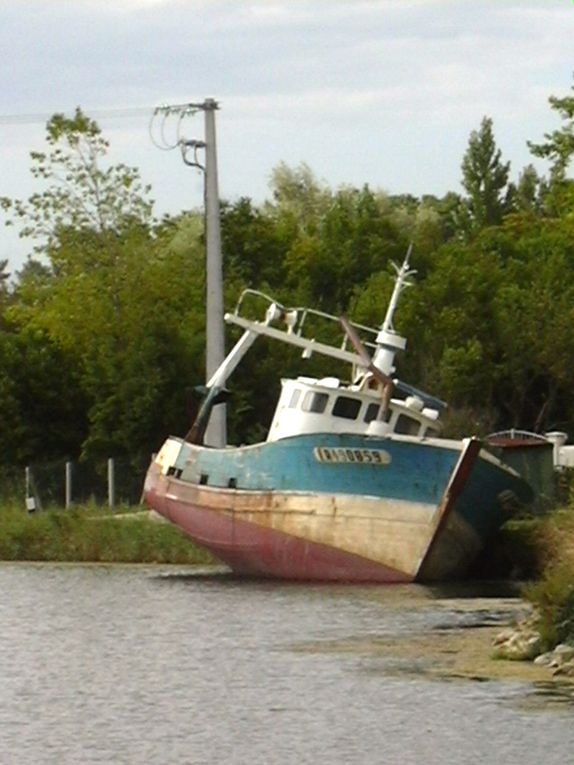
<box><xmin>0</xmin><ymin>0</ymin><xmax>574</xmax><ymax>268</ymax></box>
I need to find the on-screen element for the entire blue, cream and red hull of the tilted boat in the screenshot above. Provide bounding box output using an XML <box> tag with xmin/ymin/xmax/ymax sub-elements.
<box><xmin>144</xmin><ymin>434</ymin><xmax>529</xmax><ymax>583</ymax></box>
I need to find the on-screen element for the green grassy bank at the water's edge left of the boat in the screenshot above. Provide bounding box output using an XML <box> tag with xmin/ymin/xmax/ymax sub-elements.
<box><xmin>0</xmin><ymin>503</ymin><xmax>219</xmax><ymax>564</ymax></box>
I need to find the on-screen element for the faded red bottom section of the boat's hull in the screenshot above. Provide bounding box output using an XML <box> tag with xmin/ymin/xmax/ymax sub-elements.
<box><xmin>146</xmin><ymin>484</ymin><xmax>412</xmax><ymax>584</ymax></box>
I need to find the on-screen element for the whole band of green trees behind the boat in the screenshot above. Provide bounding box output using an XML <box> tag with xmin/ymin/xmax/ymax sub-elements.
<box><xmin>0</xmin><ymin>79</ymin><xmax>574</xmax><ymax>467</ymax></box>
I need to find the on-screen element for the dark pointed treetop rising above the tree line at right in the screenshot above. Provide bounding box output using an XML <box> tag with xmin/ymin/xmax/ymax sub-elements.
<box><xmin>462</xmin><ymin>117</ymin><xmax>512</xmax><ymax>232</ymax></box>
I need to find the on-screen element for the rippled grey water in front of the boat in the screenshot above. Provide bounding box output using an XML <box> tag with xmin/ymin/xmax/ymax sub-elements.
<box><xmin>0</xmin><ymin>564</ymin><xmax>574</xmax><ymax>765</ymax></box>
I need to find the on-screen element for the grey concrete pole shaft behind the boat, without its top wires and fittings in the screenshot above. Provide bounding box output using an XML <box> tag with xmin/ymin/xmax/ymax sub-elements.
<box><xmin>203</xmin><ymin>98</ymin><xmax>227</xmax><ymax>447</ymax></box>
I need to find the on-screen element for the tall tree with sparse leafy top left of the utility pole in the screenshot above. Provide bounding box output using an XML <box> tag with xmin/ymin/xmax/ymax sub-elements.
<box><xmin>3</xmin><ymin>110</ymin><xmax>209</xmax><ymax>462</ymax></box>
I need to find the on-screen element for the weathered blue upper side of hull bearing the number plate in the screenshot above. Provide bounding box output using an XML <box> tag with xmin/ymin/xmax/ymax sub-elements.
<box><xmin>181</xmin><ymin>434</ymin><xmax>460</xmax><ymax>505</ymax></box>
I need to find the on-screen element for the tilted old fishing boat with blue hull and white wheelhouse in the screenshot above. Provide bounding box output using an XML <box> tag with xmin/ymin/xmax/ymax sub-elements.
<box><xmin>144</xmin><ymin>255</ymin><xmax>532</xmax><ymax>582</ymax></box>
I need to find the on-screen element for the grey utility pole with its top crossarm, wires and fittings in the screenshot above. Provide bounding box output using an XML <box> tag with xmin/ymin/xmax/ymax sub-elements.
<box><xmin>152</xmin><ymin>98</ymin><xmax>227</xmax><ymax>448</ymax></box>
